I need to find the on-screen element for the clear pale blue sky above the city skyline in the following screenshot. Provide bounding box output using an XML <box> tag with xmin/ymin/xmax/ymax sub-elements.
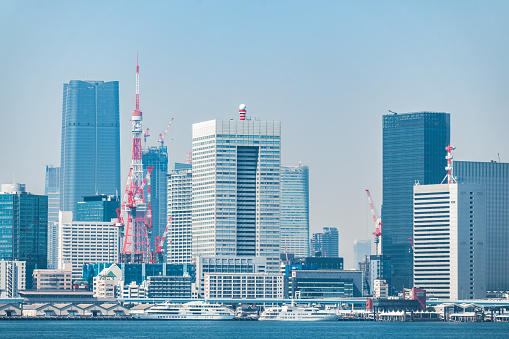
<box><xmin>0</xmin><ymin>0</ymin><xmax>509</xmax><ymax>268</ymax></box>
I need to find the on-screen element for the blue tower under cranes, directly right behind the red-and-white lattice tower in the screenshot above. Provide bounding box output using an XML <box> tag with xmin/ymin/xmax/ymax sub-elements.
<box><xmin>142</xmin><ymin>145</ymin><xmax>168</xmax><ymax>254</ymax></box>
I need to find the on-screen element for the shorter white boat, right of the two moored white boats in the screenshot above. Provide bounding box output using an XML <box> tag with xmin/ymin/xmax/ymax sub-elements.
<box><xmin>258</xmin><ymin>305</ymin><xmax>339</xmax><ymax>321</ymax></box>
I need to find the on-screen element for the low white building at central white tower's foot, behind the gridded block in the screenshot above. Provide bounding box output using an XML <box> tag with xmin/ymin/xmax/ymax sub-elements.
<box><xmin>193</xmin><ymin>256</ymin><xmax>267</xmax><ymax>296</ymax></box>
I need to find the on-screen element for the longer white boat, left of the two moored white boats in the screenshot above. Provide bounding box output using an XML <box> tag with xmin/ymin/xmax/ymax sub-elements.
<box><xmin>138</xmin><ymin>301</ymin><xmax>235</xmax><ymax>320</ymax></box>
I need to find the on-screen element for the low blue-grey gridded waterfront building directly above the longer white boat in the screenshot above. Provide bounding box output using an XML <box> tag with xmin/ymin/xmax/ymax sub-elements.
<box><xmin>146</xmin><ymin>274</ymin><xmax>192</xmax><ymax>298</ymax></box>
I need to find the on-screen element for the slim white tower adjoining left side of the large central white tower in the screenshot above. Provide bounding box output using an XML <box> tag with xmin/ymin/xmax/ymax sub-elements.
<box><xmin>166</xmin><ymin>163</ymin><xmax>193</xmax><ymax>264</ymax></box>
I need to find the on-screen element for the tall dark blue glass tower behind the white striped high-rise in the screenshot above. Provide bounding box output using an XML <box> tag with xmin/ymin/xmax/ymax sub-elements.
<box><xmin>382</xmin><ymin>112</ymin><xmax>450</xmax><ymax>293</ymax></box>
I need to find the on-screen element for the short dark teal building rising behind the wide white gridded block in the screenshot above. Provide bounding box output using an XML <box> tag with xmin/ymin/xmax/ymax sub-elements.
<box><xmin>76</xmin><ymin>194</ymin><xmax>120</xmax><ymax>222</ymax></box>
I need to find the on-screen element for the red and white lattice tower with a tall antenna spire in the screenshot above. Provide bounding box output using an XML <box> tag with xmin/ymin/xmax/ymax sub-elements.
<box><xmin>118</xmin><ymin>56</ymin><xmax>153</xmax><ymax>263</ymax></box>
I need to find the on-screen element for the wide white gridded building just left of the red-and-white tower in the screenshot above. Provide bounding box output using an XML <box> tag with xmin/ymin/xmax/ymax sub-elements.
<box><xmin>58</xmin><ymin>211</ymin><xmax>120</xmax><ymax>280</ymax></box>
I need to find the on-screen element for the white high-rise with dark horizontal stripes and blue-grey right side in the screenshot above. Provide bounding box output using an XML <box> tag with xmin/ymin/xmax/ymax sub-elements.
<box><xmin>413</xmin><ymin>184</ymin><xmax>486</xmax><ymax>300</ymax></box>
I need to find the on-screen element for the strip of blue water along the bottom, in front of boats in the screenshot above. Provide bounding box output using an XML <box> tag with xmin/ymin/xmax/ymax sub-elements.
<box><xmin>0</xmin><ymin>320</ymin><xmax>509</xmax><ymax>339</ymax></box>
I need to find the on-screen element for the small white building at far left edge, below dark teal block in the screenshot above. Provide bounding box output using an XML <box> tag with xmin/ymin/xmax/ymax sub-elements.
<box><xmin>0</xmin><ymin>259</ymin><xmax>26</xmax><ymax>298</ymax></box>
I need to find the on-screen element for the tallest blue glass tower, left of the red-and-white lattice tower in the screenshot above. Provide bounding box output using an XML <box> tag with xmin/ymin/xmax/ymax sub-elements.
<box><xmin>60</xmin><ymin>80</ymin><xmax>122</xmax><ymax>216</ymax></box>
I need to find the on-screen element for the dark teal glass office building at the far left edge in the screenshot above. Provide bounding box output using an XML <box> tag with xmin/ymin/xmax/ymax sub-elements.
<box><xmin>0</xmin><ymin>184</ymin><xmax>48</xmax><ymax>289</ymax></box>
